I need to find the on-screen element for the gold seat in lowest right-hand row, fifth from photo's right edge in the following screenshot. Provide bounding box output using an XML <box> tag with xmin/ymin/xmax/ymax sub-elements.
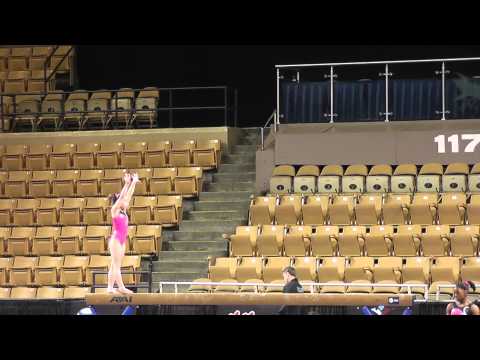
<box><xmin>345</xmin><ymin>256</ymin><xmax>374</xmax><ymax>294</ymax></box>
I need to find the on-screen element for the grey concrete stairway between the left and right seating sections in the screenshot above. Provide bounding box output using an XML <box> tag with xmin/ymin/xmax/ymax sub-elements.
<box><xmin>144</xmin><ymin>128</ymin><xmax>259</xmax><ymax>292</ymax></box>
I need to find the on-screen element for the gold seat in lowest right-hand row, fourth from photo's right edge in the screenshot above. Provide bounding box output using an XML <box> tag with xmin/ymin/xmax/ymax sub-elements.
<box><xmin>372</xmin><ymin>256</ymin><xmax>402</xmax><ymax>294</ymax></box>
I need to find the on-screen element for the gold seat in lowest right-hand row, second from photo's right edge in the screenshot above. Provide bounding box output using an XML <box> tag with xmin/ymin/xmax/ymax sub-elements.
<box><xmin>428</xmin><ymin>256</ymin><xmax>460</xmax><ymax>298</ymax></box>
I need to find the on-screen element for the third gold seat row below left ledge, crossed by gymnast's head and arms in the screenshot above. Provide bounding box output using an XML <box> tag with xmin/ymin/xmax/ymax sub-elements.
<box><xmin>0</xmin><ymin>195</ymin><xmax>183</xmax><ymax>227</ymax></box>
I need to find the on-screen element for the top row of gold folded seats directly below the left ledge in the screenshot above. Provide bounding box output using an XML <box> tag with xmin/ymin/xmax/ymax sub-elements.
<box><xmin>0</xmin><ymin>139</ymin><xmax>220</xmax><ymax>170</ymax></box>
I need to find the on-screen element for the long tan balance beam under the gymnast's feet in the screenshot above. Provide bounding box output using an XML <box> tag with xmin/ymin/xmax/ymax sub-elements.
<box><xmin>85</xmin><ymin>293</ymin><xmax>414</xmax><ymax>306</ymax></box>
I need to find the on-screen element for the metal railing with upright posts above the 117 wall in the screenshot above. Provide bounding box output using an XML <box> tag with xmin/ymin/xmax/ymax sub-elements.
<box><xmin>275</xmin><ymin>57</ymin><xmax>480</xmax><ymax>123</ymax></box>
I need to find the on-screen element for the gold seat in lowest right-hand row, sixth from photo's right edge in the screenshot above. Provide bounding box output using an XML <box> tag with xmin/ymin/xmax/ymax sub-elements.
<box><xmin>317</xmin><ymin>257</ymin><xmax>345</xmax><ymax>294</ymax></box>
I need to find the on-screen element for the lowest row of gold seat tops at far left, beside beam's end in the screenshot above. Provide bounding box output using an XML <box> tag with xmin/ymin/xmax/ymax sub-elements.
<box><xmin>0</xmin><ymin>286</ymin><xmax>90</xmax><ymax>300</ymax></box>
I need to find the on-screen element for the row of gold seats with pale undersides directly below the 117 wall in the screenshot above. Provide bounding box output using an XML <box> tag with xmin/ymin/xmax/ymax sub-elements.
<box><xmin>270</xmin><ymin>163</ymin><xmax>480</xmax><ymax>194</ymax></box>
